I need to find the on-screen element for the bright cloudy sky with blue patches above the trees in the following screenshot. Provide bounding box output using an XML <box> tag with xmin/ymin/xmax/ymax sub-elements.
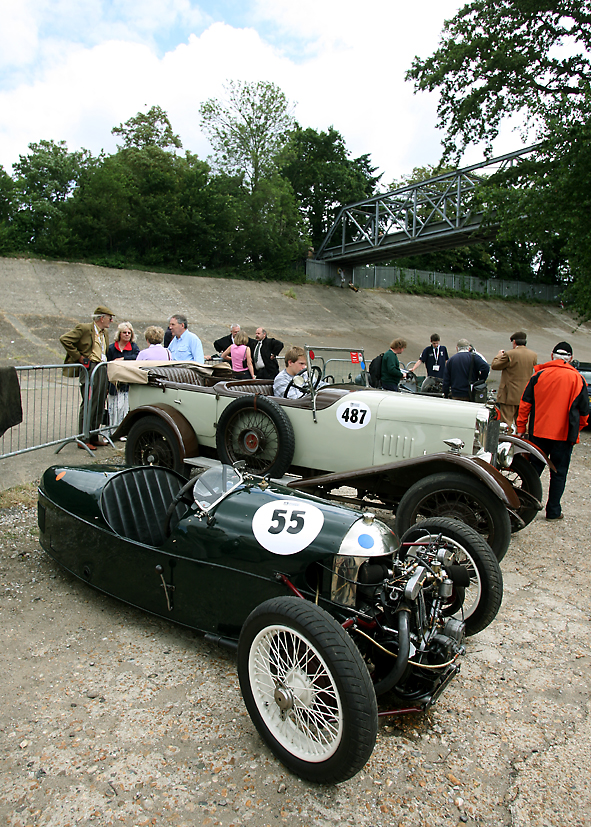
<box><xmin>0</xmin><ymin>0</ymin><xmax>521</xmax><ymax>185</ymax></box>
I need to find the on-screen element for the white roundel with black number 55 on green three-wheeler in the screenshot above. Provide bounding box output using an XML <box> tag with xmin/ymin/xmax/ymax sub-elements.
<box><xmin>252</xmin><ymin>499</ymin><xmax>324</xmax><ymax>554</ymax></box>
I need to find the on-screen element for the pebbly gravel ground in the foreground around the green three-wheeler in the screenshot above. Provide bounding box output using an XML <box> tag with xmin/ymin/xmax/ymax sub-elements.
<box><xmin>0</xmin><ymin>432</ymin><xmax>591</xmax><ymax>827</ymax></box>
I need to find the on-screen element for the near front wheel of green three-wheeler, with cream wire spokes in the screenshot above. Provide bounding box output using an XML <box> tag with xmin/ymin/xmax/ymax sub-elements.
<box><xmin>238</xmin><ymin>597</ymin><xmax>378</xmax><ymax>784</ymax></box>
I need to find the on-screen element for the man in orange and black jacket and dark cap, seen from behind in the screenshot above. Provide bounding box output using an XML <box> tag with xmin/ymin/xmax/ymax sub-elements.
<box><xmin>517</xmin><ymin>342</ymin><xmax>589</xmax><ymax>520</ymax></box>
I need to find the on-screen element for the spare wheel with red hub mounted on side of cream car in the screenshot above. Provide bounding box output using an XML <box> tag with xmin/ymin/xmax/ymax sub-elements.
<box><xmin>216</xmin><ymin>394</ymin><xmax>295</xmax><ymax>477</ymax></box>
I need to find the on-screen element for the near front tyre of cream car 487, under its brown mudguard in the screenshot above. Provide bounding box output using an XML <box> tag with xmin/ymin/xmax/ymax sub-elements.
<box><xmin>395</xmin><ymin>473</ymin><xmax>511</xmax><ymax>562</ymax></box>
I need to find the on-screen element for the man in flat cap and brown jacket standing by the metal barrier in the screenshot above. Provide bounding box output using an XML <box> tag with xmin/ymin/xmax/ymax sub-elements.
<box><xmin>60</xmin><ymin>305</ymin><xmax>114</xmax><ymax>451</ymax></box>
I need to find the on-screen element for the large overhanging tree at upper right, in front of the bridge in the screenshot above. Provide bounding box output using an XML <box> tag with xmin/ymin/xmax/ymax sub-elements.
<box><xmin>407</xmin><ymin>0</ymin><xmax>591</xmax><ymax>318</ymax></box>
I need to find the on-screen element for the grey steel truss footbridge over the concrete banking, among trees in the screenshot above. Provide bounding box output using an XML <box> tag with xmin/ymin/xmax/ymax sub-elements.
<box><xmin>315</xmin><ymin>145</ymin><xmax>539</xmax><ymax>266</ymax></box>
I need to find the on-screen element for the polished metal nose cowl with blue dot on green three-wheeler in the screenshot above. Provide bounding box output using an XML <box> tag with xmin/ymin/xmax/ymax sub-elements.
<box><xmin>330</xmin><ymin>514</ymin><xmax>398</xmax><ymax>608</ymax></box>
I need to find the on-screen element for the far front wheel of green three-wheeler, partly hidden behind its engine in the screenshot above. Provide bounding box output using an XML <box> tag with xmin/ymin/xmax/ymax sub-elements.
<box><xmin>401</xmin><ymin>517</ymin><xmax>503</xmax><ymax>635</ymax></box>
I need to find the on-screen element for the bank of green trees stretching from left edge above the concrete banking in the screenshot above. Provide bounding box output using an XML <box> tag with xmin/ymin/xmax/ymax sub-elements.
<box><xmin>0</xmin><ymin>96</ymin><xmax>373</xmax><ymax>282</ymax></box>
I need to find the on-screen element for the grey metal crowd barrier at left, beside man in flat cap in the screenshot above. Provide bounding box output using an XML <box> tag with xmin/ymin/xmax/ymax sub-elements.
<box><xmin>0</xmin><ymin>362</ymin><xmax>110</xmax><ymax>459</ymax></box>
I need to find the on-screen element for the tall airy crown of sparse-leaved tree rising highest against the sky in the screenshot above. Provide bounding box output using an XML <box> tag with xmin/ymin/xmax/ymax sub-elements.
<box><xmin>199</xmin><ymin>81</ymin><xmax>294</xmax><ymax>192</ymax></box>
